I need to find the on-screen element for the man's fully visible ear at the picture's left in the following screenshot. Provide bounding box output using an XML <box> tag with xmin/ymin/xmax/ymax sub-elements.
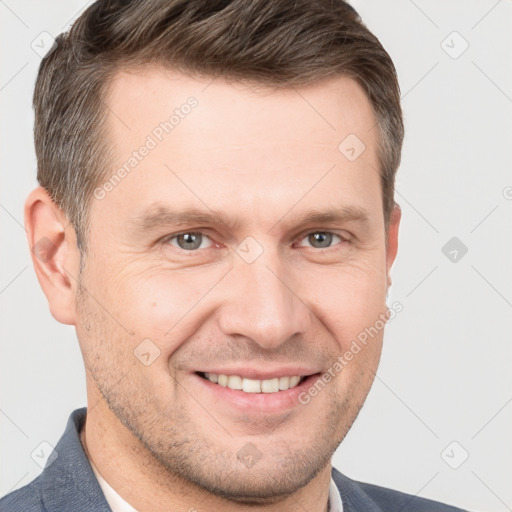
<box><xmin>25</xmin><ymin>187</ymin><xmax>80</xmax><ymax>325</ymax></box>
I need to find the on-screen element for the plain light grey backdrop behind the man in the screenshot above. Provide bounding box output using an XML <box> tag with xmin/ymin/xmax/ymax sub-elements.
<box><xmin>0</xmin><ymin>0</ymin><xmax>512</xmax><ymax>512</ymax></box>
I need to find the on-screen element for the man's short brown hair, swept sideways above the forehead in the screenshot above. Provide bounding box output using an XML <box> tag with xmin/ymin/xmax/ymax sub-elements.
<box><xmin>34</xmin><ymin>0</ymin><xmax>404</xmax><ymax>253</ymax></box>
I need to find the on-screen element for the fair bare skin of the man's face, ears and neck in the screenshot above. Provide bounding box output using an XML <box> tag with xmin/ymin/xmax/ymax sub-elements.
<box><xmin>26</xmin><ymin>67</ymin><xmax>400</xmax><ymax>511</ymax></box>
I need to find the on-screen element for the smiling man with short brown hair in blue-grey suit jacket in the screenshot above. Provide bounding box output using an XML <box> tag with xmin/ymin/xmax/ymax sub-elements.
<box><xmin>0</xmin><ymin>0</ymin><xmax>470</xmax><ymax>512</ymax></box>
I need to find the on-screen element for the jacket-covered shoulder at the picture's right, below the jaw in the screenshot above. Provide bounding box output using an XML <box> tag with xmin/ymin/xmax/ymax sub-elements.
<box><xmin>332</xmin><ymin>468</ymin><xmax>467</xmax><ymax>512</ymax></box>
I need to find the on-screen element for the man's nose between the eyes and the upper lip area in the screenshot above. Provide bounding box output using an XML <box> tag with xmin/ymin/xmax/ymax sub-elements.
<box><xmin>219</xmin><ymin>248</ymin><xmax>312</xmax><ymax>350</ymax></box>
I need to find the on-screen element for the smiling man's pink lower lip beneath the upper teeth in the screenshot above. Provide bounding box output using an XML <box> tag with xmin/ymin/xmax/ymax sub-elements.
<box><xmin>191</xmin><ymin>373</ymin><xmax>321</xmax><ymax>414</ymax></box>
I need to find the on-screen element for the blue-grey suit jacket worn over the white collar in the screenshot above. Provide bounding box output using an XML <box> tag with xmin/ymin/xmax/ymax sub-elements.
<box><xmin>0</xmin><ymin>407</ymin><xmax>470</xmax><ymax>512</ymax></box>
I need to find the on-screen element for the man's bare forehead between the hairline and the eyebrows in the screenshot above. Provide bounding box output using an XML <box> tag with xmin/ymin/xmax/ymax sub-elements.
<box><xmin>98</xmin><ymin>66</ymin><xmax>381</xmax><ymax>228</ymax></box>
